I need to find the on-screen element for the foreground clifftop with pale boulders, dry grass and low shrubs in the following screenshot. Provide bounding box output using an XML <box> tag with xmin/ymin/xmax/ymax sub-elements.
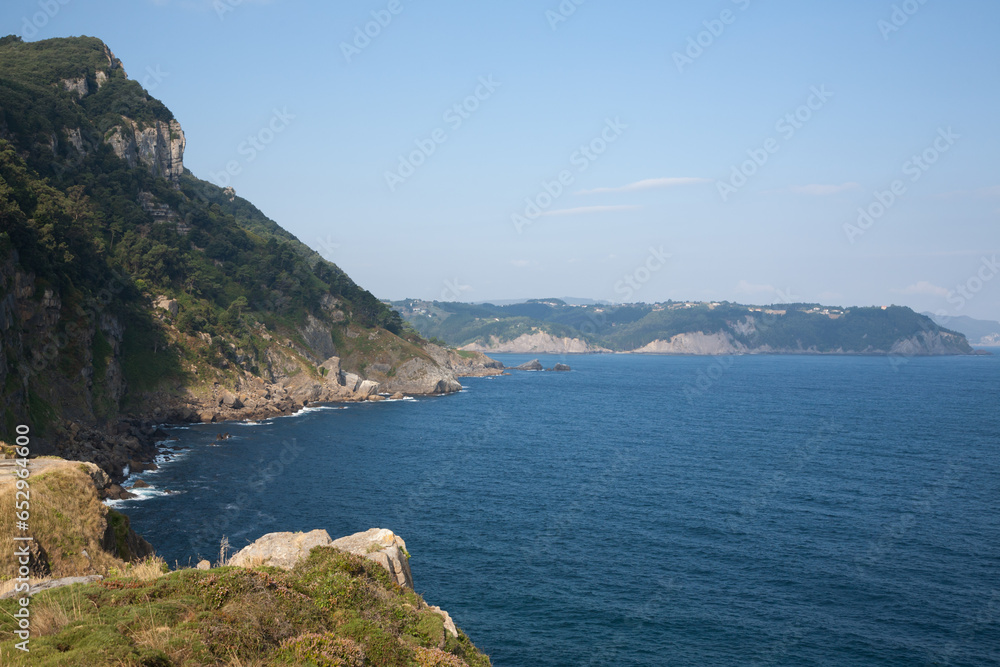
<box><xmin>0</xmin><ymin>459</ymin><xmax>490</xmax><ymax>667</ymax></box>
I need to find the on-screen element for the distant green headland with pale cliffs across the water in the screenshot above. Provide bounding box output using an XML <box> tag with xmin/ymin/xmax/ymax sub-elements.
<box><xmin>393</xmin><ymin>299</ymin><xmax>972</xmax><ymax>355</ymax></box>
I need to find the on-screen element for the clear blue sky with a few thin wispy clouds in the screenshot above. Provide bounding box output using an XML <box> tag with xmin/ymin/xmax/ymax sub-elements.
<box><xmin>0</xmin><ymin>0</ymin><xmax>1000</xmax><ymax>320</ymax></box>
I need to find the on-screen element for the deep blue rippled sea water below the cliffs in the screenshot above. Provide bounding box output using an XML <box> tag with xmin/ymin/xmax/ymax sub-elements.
<box><xmin>122</xmin><ymin>355</ymin><xmax>1000</xmax><ymax>667</ymax></box>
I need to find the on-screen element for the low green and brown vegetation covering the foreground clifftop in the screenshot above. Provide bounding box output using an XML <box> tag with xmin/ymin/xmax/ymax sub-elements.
<box><xmin>0</xmin><ymin>547</ymin><xmax>490</xmax><ymax>667</ymax></box>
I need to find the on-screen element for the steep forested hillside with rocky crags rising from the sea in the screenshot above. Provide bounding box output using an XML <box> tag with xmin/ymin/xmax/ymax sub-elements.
<box><xmin>0</xmin><ymin>36</ymin><xmax>500</xmax><ymax>476</ymax></box>
